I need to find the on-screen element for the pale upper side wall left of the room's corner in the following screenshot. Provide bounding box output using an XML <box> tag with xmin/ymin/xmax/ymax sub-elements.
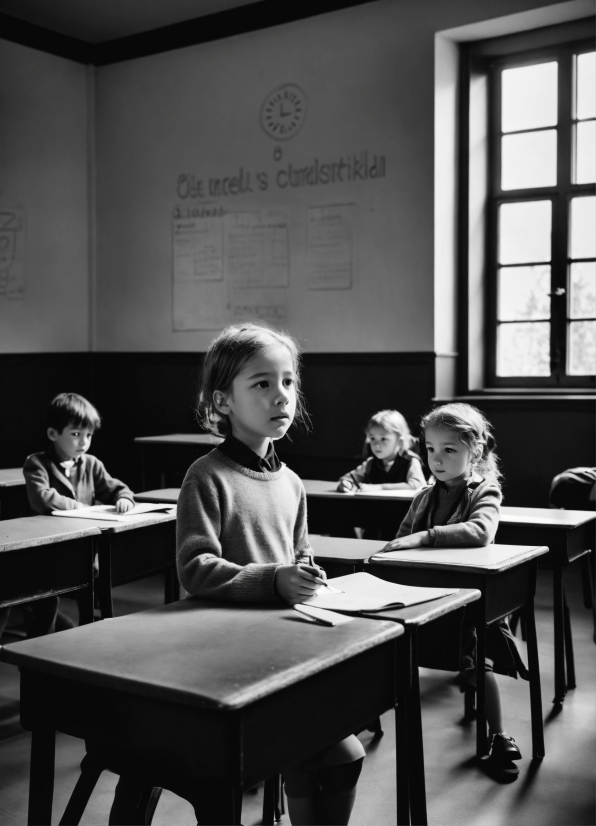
<box><xmin>0</xmin><ymin>40</ymin><xmax>90</xmax><ymax>353</ymax></box>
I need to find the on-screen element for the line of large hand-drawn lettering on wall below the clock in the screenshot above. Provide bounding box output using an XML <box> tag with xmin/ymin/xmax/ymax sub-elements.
<box><xmin>176</xmin><ymin>150</ymin><xmax>387</xmax><ymax>200</ymax></box>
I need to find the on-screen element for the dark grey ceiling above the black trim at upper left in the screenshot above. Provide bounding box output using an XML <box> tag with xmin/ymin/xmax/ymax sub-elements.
<box><xmin>0</xmin><ymin>0</ymin><xmax>264</xmax><ymax>43</ymax></box>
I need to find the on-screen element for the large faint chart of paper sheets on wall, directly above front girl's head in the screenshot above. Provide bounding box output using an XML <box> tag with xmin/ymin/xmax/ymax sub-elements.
<box><xmin>172</xmin><ymin>207</ymin><xmax>289</xmax><ymax>332</ymax></box>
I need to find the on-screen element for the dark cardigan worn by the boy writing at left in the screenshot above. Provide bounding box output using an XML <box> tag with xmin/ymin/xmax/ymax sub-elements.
<box><xmin>23</xmin><ymin>447</ymin><xmax>134</xmax><ymax>513</ymax></box>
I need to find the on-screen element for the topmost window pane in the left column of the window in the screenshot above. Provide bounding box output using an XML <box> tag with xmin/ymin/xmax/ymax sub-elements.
<box><xmin>501</xmin><ymin>62</ymin><xmax>558</xmax><ymax>132</ymax></box>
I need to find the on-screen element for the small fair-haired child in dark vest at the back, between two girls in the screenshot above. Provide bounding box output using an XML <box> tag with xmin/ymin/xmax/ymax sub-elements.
<box><xmin>337</xmin><ymin>410</ymin><xmax>426</xmax><ymax>492</ymax></box>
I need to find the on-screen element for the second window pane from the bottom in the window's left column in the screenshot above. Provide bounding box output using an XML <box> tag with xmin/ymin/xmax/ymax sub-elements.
<box><xmin>499</xmin><ymin>265</ymin><xmax>550</xmax><ymax>321</ymax></box>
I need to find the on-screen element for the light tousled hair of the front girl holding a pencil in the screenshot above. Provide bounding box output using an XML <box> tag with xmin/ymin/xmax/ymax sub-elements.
<box><xmin>196</xmin><ymin>322</ymin><xmax>308</xmax><ymax>436</ymax></box>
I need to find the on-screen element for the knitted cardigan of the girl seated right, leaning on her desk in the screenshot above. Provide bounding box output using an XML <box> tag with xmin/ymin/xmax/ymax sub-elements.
<box><xmin>397</xmin><ymin>476</ymin><xmax>503</xmax><ymax>548</ymax></box>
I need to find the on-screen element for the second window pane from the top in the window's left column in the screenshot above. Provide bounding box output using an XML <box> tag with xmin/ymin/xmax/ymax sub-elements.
<box><xmin>501</xmin><ymin>130</ymin><xmax>560</xmax><ymax>189</ymax></box>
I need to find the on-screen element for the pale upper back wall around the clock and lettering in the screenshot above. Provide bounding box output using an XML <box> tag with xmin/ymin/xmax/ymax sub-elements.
<box><xmin>92</xmin><ymin>0</ymin><xmax>568</xmax><ymax>352</ymax></box>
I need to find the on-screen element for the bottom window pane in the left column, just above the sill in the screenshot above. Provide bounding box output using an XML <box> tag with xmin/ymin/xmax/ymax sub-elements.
<box><xmin>497</xmin><ymin>321</ymin><xmax>550</xmax><ymax>376</ymax></box>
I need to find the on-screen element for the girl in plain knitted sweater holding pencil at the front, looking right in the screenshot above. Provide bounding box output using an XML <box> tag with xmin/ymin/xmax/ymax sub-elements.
<box><xmin>110</xmin><ymin>323</ymin><xmax>364</xmax><ymax>826</ymax></box>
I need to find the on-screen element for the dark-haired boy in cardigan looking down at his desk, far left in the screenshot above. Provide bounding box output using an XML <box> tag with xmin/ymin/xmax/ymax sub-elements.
<box><xmin>23</xmin><ymin>393</ymin><xmax>134</xmax><ymax>637</ymax></box>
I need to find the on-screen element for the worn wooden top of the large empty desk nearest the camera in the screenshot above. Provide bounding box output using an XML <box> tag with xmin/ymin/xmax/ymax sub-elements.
<box><xmin>0</xmin><ymin>599</ymin><xmax>404</xmax><ymax>711</ymax></box>
